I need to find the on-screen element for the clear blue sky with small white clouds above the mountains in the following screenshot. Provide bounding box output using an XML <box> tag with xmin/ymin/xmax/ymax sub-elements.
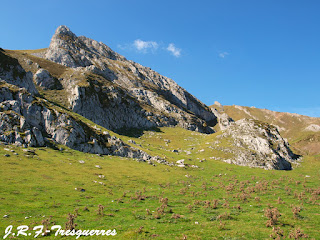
<box><xmin>0</xmin><ymin>0</ymin><xmax>320</xmax><ymax>117</ymax></box>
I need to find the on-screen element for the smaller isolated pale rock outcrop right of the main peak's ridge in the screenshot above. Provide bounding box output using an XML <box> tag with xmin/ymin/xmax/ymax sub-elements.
<box><xmin>221</xmin><ymin>119</ymin><xmax>297</xmax><ymax>170</ymax></box>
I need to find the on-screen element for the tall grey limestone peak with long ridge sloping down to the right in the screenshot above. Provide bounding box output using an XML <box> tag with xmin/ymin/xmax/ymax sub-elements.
<box><xmin>37</xmin><ymin>26</ymin><xmax>217</xmax><ymax>133</ymax></box>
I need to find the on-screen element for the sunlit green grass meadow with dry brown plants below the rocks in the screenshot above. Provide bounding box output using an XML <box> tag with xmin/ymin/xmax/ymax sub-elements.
<box><xmin>0</xmin><ymin>128</ymin><xmax>320</xmax><ymax>239</ymax></box>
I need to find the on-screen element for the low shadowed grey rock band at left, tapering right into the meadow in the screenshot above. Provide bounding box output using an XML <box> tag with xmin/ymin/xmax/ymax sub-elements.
<box><xmin>0</xmin><ymin>81</ymin><xmax>156</xmax><ymax>161</ymax></box>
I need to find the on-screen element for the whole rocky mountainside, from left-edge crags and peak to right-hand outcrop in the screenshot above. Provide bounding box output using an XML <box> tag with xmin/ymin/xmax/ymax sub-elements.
<box><xmin>0</xmin><ymin>26</ymin><xmax>295</xmax><ymax>169</ymax></box>
